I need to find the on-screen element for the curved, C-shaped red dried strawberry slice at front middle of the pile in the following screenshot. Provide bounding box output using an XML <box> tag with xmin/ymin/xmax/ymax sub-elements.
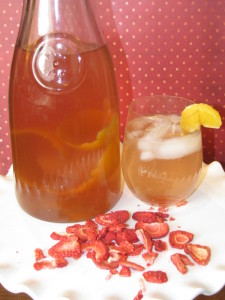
<box><xmin>81</xmin><ymin>240</ymin><xmax>109</xmax><ymax>262</ymax></box>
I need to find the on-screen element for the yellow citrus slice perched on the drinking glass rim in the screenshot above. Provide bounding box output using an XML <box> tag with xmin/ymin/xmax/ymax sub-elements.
<box><xmin>180</xmin><ymin>103</ymin><xmax>222</xmax><ymax>133</ymax></box>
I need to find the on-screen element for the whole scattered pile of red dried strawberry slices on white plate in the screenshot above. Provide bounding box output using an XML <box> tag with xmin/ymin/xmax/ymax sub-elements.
<box><xmin>34</xmin><ymin>209</ymin><xmax>210</xmax><ymax>299</ymax></box>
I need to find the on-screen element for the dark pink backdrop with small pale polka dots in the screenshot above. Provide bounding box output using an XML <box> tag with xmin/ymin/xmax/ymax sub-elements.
<box><xmin>0</xmin><ymin>0</ymin><xmax>225</xmax><ymax>174</ymax></box>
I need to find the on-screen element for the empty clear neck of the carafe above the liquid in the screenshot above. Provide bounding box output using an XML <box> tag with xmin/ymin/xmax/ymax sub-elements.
<box><xmin>17</xmin><ymin>0</ymin><xmax>104</xmax><ymax>48</ymax></box>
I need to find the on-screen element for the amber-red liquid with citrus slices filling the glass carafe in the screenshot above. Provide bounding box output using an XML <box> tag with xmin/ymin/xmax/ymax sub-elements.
<box><xmin>9</xmin><ymin>39</ymin><xmax>121</xmax><ymax>222</ymax></box>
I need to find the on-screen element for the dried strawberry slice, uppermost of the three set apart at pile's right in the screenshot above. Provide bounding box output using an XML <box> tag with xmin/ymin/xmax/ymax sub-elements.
<box><xmin>169</xmin><ymin>230</ymin><xmax>194</xmax><ymax>249</ymax></box>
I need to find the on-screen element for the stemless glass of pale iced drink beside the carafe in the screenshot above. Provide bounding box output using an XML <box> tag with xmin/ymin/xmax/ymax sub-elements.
<box><xmin>122</xmin><ymin>96</ymin><xmax>202</xmax><ymax>207</ymax></box>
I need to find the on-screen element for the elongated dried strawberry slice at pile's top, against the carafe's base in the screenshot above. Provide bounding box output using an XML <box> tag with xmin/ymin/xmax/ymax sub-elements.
<box><xmin>95</xmin><ymin>210</ymin><xmax>130</xmax><ymax>226</ymax></box>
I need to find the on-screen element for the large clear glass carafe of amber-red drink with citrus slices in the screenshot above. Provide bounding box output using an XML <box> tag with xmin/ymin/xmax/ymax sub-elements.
<box><xmin>9</xmin><ymin>0</ymin><xmax>121</xmax><ymax>222</ymax></box>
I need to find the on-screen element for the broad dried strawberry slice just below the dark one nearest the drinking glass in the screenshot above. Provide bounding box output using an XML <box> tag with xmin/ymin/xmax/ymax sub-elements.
<box><xmin>135</xmin><ymin>222</ymin><xmax>169</xmax><ymax>239</ymax></box>
